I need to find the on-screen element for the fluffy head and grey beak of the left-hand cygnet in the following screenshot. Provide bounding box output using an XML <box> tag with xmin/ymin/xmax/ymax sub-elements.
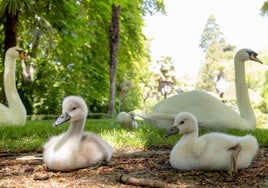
<box><xmin>53</xmin><ymin>96</ymin><xmax>88</xmax><ymax>126</ymax></box>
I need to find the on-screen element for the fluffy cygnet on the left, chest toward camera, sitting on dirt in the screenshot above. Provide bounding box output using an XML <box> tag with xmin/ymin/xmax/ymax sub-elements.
<box><xmin>43</xmin><ymin>96</ymin><xmax>113</xmax><ymax>171</ymax></box>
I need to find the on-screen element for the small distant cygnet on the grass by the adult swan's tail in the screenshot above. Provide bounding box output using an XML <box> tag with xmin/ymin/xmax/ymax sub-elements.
<box><xmin>117</xmin><ymin>111</ymin><xmax>138</xmax><ymax>129</ymax></box>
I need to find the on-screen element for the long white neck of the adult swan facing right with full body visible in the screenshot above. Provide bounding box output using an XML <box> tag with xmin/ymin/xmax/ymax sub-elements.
<box><xmin>234</xmin><ymin>57</ymin><xmax>256</xmax><ymax>126</ymax></box>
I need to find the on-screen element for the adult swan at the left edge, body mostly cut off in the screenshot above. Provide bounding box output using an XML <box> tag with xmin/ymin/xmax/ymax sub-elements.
<box><xmin>0</xmin><ymin>46</ymin><xmax>28</xmax><ymax>126</ymax></box>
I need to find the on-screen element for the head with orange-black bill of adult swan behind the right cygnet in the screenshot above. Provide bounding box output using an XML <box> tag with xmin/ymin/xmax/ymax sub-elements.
<box><xmin>235</xmin><ymin>48</ymin><xmax>262</xmax><ymax>64</ymax></box>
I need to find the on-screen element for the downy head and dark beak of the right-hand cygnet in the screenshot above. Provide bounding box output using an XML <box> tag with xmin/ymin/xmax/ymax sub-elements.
<box><xmin>165</xmin><ymin>112</ymin><xmax>197</xmax><ymax>137</ymax></box>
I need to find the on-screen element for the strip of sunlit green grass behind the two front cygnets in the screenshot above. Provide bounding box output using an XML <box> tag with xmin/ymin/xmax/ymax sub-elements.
<box><xmin>0</xmin><ymin>119</ymin><xmax>268</xmax><ymax>152</ymax></box>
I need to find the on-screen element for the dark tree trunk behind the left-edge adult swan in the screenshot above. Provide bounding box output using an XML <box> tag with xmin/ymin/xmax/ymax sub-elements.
<box><xmin>0</xmin><ymin>10</ymin><xmax>19</xmax><ymax>105</ymax></box>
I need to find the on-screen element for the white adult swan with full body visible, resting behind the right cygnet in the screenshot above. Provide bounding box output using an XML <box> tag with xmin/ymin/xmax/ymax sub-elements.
<box><xmin>136</xmin><ymin>49</ymin><xmax>262</xmax><ymax>130</ymax></box>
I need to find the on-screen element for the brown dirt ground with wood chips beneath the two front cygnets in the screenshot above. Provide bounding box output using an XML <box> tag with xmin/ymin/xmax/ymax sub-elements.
<box><xmin>0</xmin><ymin>148</ymin><xmax>268</xmax><ymax>188</ymax></box>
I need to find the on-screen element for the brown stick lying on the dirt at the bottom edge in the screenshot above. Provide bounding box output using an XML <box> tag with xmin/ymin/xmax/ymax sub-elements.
<box><xmin>115</xmin><ymin>174</ymin><xmax>179</xmax><ymax>188</ymax></box>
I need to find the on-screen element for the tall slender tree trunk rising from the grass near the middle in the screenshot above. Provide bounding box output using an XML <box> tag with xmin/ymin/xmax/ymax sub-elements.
<box><xmin>109</xmin><ymin>5</ymin><xmax>121</xmax><ymax>117</ymax></box>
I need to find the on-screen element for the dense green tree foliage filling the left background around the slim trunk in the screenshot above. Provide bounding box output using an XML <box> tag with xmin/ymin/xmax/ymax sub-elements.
<box><xmin>0</xmin><ymin>0</ymin><xmax>164</xmax><ymax>114</ymax></box>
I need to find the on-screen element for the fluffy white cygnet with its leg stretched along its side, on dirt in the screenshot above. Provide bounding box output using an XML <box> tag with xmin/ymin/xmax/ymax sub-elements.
<box><xmin>166</xmin><ymin>112</ymin><xmax>258</xmax><ymax>175</ymax></box>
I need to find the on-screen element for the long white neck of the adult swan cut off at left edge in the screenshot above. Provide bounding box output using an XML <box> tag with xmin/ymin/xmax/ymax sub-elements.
<box><xmin>4</xmin><ymin>56</ymin><xmax>26</xmax><ymax>116</ymax></box>
